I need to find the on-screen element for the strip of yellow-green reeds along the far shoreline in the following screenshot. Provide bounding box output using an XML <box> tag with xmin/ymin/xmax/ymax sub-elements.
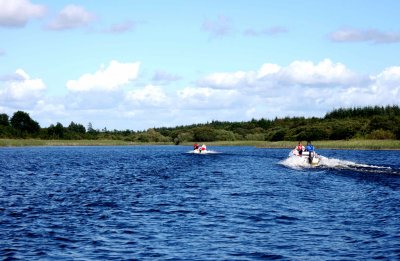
<box><xmin>0</xmin><ymin>139</ymin><xmax>400</xmax><ymax>150</ymax></box>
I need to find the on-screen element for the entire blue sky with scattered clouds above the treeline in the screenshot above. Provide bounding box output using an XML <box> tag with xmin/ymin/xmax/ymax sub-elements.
<box><xmin>0</xmin><ymin>0</ymin><xmax>400</xmax><ymax>130</ymax></box>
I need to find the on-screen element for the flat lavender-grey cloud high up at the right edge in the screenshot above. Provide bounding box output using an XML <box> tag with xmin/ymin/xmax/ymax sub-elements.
<box><xmin>329</xmin><ymin>28</ymin><xmax>400</xmax><ymax>44</ymax></box>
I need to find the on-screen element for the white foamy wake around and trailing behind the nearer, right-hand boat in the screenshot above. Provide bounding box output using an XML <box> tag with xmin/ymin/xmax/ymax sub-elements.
<box><xmin>280</xmin><ymin>156</ymin><xmax>400</xmax><ymax>175</ymax></box>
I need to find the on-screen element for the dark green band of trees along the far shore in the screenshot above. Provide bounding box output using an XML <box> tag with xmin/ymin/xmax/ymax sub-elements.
<box><xmin>0</xmin><ymin>106</ymin><xmax>400</xmax><ymax>144</ymax></box>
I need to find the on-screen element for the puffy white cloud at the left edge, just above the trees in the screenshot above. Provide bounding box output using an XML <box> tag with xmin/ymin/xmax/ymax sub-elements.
<box><xmin>0</xmin><ymin>69</ymin><xmax>46</xmax><ymax>107</ymax></box>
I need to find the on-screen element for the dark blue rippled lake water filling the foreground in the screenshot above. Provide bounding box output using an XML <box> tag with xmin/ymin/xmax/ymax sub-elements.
<box><xmin>0</xmin><ymin>146</ymin><xmax>400</xmax><ymax>260</ymax></box>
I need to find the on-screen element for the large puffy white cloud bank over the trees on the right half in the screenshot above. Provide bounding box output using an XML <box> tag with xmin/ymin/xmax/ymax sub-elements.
<box><xmin>193</xmin><ymin>59</ymin><xmax>400</xmax><ymax>117</ymax></box>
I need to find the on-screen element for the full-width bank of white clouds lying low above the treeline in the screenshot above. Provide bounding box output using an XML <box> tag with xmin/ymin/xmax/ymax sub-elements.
<box><xmin>0</xmin><ymin>59</ymin><xmax>400</xmax><ymax>130</ymax></box>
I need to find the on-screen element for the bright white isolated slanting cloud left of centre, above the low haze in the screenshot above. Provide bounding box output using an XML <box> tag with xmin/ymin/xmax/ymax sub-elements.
<box><xmin>66</xmin><ymin>61</ymin><xmax>140</xmax><ymax>92</ymax></box>
